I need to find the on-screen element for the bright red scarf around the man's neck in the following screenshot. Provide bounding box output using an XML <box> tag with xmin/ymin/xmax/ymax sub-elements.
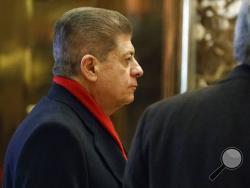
<box><xmin>53</xmin><ymin>76</ymin><xmax>127</xmax><ymax>160</ymax></box>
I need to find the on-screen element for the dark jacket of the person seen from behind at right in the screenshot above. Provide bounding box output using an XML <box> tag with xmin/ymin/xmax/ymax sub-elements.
<box><xmin>124</xmin><ymin>65</ymin><xmax>250</xmax><ymax>188</ymax></box>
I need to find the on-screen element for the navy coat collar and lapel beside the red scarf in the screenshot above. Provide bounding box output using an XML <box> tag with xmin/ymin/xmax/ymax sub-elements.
<box><xmin>48</xmin><ymin>84</ymin><xmax>126</xmax><ymax>182</ymax></box>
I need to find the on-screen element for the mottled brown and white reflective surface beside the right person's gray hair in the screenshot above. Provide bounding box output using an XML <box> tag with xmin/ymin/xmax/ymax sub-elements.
<box><xmin>190</xmin><ymin>0</ymin><xmax>241</xmax><ymax>89</ymax></box>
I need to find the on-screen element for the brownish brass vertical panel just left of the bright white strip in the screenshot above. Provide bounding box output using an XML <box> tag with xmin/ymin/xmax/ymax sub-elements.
<box><xmin>163</xmin><ymin>0</ymin><xmax>182</xmax><ymax>97</ymax></box>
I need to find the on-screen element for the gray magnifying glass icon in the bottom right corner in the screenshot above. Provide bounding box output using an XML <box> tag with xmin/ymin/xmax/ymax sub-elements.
<box><xmin>209</xmin><ymin>147</ymin><xmax>243</xmax><ymax>181</ymax></box>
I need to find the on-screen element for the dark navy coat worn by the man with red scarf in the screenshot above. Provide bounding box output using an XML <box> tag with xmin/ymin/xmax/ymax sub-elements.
<box><xmin>4</xmin><ymin>85</ymin><xmax>125</xmax><ymax>188</ymax></box>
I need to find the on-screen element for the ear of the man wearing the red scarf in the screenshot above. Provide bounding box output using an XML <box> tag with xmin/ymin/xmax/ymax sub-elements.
<box><xmin>81</xmin><ymin>54</ymin><xmax>98</xmax><ymax>82</ymax></box>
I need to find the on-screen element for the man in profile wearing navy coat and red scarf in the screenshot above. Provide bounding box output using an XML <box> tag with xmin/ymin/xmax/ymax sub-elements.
<box><xmin>3</xmin><ymin>7</ymin><xmax>143</xmax><ymax>188</ymax></box>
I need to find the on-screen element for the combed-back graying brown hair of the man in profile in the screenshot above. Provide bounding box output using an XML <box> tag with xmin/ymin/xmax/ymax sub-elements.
<box><xmin>53</xmin><ymin>7</ymin><xmax>132</xmax><ymax>76</ymax></box>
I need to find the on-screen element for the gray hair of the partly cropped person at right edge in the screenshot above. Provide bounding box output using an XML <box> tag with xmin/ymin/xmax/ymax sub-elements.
<box><xmin>234</xmin><ymin>0</ymin><xmax>250</xmax><ymax>64</ymax></box>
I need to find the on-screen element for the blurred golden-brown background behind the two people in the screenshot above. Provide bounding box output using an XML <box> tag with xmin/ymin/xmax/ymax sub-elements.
<box><xmin>0</xmin><ymin>0</ymin><xmax>241</xmax><ymax>183</ymax></box>
